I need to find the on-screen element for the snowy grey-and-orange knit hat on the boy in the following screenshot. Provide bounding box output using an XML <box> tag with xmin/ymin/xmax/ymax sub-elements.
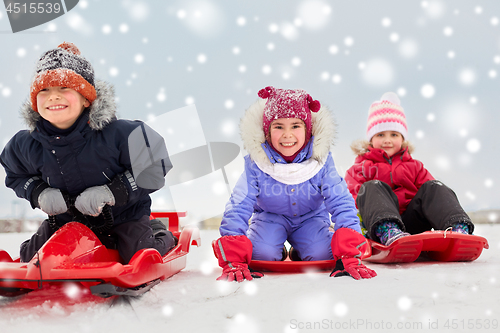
<box><xmin>30</xmin><ymin>42</ymin><xmax>96</xmax><ymax>112</ymax></box>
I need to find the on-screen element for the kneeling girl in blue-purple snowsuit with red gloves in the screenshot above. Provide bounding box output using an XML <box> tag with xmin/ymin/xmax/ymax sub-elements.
<box><xmin>213</xmin><ymin>87</ymin><xmax>376</xmax><ymax>282</ymax></box>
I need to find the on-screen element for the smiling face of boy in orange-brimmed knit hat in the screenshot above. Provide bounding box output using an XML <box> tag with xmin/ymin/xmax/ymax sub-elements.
<box><xmin>36</xmin><ymin>87</ymin><xmax>90</xmax><ymax>129</ymax></box>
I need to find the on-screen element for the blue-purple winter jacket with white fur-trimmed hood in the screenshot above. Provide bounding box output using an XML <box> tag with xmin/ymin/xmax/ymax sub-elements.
<box><xmin>220</xmin><ymin>100</ymin><xmax>361</xmax><ymax>237</ymax></box>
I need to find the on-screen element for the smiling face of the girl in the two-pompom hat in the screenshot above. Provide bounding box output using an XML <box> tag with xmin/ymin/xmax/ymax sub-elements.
<box><xmin>269</xmin><ymin>118</ymin><xmax>306</xmax><ymax>156</ymax></box>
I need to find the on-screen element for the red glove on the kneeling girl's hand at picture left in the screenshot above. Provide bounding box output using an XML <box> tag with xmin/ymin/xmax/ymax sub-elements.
<box><xmin>212</xmin><ymin>235</ymin><xmax>264</xmax><ymax>282</ymax></box>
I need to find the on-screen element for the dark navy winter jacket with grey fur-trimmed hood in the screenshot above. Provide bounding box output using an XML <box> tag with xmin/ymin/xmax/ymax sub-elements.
<box><xmin>0</xmin><ymin>81</ymin><xmax>171</xmax><ymax>224</ymax></box>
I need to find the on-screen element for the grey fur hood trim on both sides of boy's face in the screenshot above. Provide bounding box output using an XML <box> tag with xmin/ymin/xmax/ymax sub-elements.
<box><xmin>21</xmin><ymin>80</ymin><xmax>116</xmax><ymax>132</ymax></box>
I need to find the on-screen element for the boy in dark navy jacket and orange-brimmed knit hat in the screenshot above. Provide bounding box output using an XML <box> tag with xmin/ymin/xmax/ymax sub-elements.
<box><xmin>0</xmin><ymin>43</ymin><xmax>175</xmax><ymax>263</ymax></box>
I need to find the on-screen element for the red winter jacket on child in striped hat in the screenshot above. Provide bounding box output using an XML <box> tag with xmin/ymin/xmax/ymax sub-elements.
<box><xmin>345</xmin><ymin>141</ymin><xmax>434</xmax><ymax>214</ymax></box>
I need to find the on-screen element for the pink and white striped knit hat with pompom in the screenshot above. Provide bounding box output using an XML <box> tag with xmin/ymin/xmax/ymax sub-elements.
<box><xmin>366</xmin><ymin>92</ymin><xmax>408</xmax><ymax>140</ymax></box>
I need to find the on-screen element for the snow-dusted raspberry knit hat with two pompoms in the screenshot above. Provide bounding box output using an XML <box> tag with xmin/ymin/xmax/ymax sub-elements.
<box><xmin>258</xmin><ymin>87</ymin><xmax>321</xmax><ymax>137</ymax></box>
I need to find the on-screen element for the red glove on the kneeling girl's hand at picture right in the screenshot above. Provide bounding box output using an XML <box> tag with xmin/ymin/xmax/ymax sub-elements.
<box><xmin>330</xmin><ymin>228</ymin><xmax>377</xmax><ymax>280</ymax></box>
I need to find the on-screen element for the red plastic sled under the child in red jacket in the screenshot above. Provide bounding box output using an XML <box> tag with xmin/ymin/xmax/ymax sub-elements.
<box><xmin>364</xmin><ymin>230</ymin><xmax>489</xmax><ymax>264</ymax></box>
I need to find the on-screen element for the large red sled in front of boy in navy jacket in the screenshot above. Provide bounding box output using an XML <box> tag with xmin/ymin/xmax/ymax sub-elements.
<box><xmin>0</xmin><ymin>212</ymin><xmax>201</xmax><ymax>297</ymax></box>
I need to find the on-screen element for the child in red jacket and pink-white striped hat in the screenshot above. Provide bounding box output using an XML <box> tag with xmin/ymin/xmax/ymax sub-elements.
<box><xmin>346</xmin><ymin>92</ymin><xmax>474</xmax><ymax>245</ymax></box>
